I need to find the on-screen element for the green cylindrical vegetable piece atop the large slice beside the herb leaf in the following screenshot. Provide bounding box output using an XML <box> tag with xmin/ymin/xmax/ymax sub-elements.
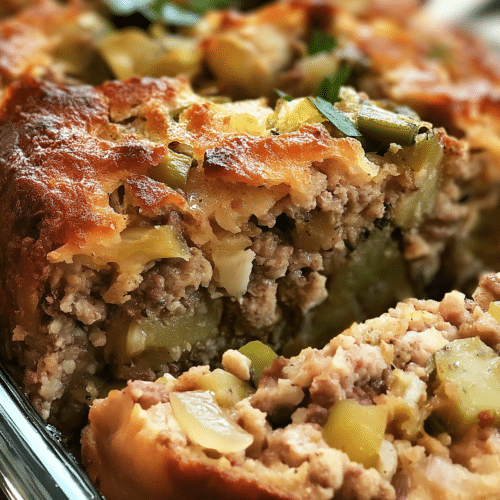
<box><xmin>357</xmin><ymin>104</ymin><xmax>422</xmax><ymax>146</ymax></box>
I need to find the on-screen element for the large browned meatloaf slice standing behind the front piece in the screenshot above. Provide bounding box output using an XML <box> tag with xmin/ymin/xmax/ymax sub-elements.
<box><xmin>0</xmin><ymin>73</ymin><xmax>481</xmax><ymax>427</ymax></box>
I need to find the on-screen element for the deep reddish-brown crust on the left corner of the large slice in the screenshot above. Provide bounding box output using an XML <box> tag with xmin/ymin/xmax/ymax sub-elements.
<box><xmin>0</xmin><ymin>75</ymin><xmax>165</xmax><ymax>253</ymax></box>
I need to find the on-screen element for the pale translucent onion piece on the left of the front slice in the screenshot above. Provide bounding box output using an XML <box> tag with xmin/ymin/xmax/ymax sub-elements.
<box><xmin>170</xmin><ymin>391</ymin><xmax>253</xmax><ymax>453</ymax></box>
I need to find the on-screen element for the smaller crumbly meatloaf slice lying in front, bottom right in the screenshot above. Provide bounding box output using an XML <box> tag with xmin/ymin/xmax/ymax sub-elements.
<box><xmin>83</xmin><ymin>274</ymin><xmax>500</xmax><ymax>500</ymax></box>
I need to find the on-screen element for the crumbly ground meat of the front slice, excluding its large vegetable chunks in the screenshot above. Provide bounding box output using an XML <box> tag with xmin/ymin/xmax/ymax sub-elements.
<box><xmin>83</xmin><ymin>275</ymin><xmax>500</xmax><ymax>500</ymax></box>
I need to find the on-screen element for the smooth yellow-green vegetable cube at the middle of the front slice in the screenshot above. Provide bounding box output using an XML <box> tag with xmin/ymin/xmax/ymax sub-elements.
<box><xmin>323</xmin><ymin>399</ymin><xmax>387</xmax><ymax>469</ymax></box>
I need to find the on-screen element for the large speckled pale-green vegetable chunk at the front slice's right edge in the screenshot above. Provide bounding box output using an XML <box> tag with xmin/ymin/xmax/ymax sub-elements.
<box><xmin>434</xmin><ymin>337</ymin><xmax>500</xmax><ymax>435</ymax></box>
